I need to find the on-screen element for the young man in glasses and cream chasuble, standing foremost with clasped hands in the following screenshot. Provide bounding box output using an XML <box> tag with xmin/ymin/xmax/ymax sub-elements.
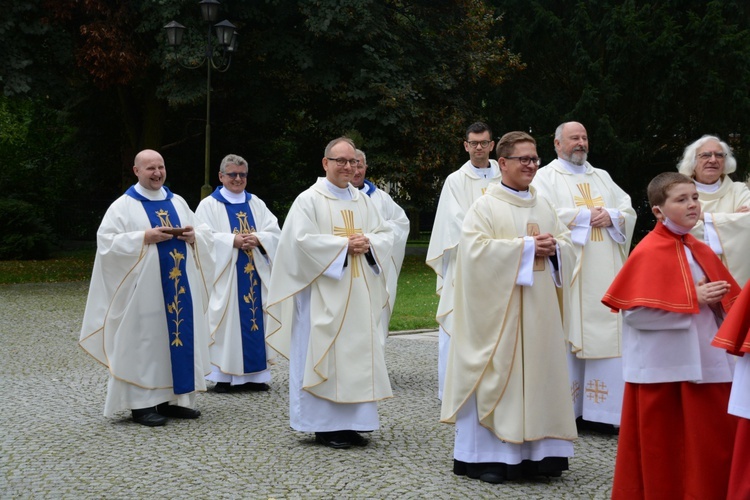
<box><xmin>441</xmin><ymin>132</ymin><xmax>579</xmax><ymax>483</ymax></box>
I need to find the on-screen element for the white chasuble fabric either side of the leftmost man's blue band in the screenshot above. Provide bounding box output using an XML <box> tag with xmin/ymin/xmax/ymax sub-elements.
<box><xmin>80</xmin><ymin>186</ymin><xmax>213</xmax><ymax>416</ymax></box>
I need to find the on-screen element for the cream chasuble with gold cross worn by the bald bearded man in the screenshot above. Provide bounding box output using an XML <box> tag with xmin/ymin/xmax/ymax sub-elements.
<box><xmin>532</xmin><ymin>160</ymin><xmax>636</xmax><ymax>359</ymax></box>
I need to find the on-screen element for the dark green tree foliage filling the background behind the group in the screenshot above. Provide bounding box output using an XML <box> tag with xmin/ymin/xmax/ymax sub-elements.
<box><xmin>0</xmin><ymin>0</ymin><xmax>750</xmax><ymax>244</ymax></box>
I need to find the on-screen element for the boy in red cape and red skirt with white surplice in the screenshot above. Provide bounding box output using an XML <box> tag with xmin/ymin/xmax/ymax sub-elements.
<box><xmin>602</xmin><ymin>172</ymin><xmax>740</xmax><ymax>500</ymax></box>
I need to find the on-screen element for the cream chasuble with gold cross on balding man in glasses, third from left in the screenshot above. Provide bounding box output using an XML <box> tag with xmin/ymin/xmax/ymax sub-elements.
<box><xmin>266</xmin><ymin>178</ymin><xmax>393</xmax><ymax>403</ymax></box>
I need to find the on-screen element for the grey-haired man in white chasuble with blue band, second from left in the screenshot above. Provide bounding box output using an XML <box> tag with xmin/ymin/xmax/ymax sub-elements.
<box><xmin>195</xmin><ymin>154</ymin><xmax>281</xmax><ymax>393</ymax></box>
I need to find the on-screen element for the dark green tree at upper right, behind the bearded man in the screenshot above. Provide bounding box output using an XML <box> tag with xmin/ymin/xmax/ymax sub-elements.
<box><xmin>490</xmin><ymin>0</ymin><xmax>750</xmax><ymax>242</ymax></box>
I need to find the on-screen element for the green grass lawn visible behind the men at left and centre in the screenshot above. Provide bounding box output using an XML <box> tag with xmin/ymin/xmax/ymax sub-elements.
<box><xmin>0</xmin><ymin>247</ymin><xmax>438</xmax><ymax>331</ymax></box>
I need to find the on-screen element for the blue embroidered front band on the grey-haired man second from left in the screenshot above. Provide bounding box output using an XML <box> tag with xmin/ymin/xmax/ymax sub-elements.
<box><xmin>211</xmin><ymin>187</ymin><xmax>267</xmax><ymax>373</ymax></box>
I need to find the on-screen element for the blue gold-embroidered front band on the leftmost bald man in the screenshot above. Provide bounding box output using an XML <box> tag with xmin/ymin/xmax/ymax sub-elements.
<box><xmin>125</xmin><ymin>186</ymin><xmax>195</xmax><ymax>394</ymax></box>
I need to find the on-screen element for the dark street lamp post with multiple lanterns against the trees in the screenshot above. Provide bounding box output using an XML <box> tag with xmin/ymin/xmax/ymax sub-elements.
<box><xmin>164</xmin><ymin>0</ymin><xmax>238</xmax><ymax>199</ymax></box>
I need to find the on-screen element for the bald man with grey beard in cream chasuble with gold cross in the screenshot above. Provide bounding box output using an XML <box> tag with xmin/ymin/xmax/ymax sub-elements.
<box><xmin>532</xmin><ymin>122</ymin><xmax>636</xmax><ymax>434</ymax></box>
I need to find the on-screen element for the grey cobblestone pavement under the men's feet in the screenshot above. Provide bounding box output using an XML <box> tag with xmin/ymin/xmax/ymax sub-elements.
<box><xmin>0</xmin><ymin>283</ymin><xmax>617</xmax><ymax>499</ymax></box>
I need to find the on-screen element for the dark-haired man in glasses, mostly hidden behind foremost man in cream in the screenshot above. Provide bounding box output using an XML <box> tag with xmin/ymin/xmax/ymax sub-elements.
<box><xmin>426</xmin><ymin>122</ymin><xmax>500</xmax><ymax>398</ymax></box>
